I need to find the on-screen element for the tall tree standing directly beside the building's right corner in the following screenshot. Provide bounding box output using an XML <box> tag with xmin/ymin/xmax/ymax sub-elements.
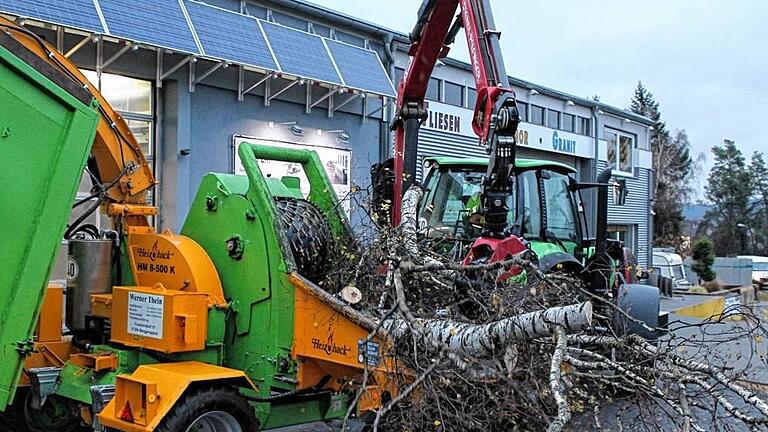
<box><xmin>629</xmin><ymin>82</ymin><xmax>693</xmax><ymax>249</ymax></box>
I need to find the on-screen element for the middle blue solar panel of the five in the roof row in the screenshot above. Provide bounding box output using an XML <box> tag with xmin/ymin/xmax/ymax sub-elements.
<box><xmin>186</xmin><ymin>2</ymin><xmax>277</xmax><ymax>70</ymax></box>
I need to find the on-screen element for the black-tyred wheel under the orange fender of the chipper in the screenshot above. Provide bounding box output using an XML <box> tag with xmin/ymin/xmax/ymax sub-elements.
<box><xmin>156</xmin><ymin>387</ymin><xmax>259</xmax><ymax>432</ymax></box>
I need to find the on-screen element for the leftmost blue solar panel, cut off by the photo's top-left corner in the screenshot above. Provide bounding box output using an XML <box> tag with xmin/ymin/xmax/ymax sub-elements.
<box><xmin>0</xmin><ymin>0</ymin><xmax>104</xmax><ymax>33</ymax></box>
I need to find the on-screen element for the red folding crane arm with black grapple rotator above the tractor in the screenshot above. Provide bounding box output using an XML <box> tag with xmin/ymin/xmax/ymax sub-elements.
<box><xmin>391</xmin><ymin>0</ymin><xmax>520</xmax><ymax>238</ymax></box>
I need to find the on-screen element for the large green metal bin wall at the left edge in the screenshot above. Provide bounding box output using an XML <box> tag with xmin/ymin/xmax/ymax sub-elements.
<box><xmin>0</xmin><ymin>34</ymin><xmax>99</xmax><ymax>410</ymax></box>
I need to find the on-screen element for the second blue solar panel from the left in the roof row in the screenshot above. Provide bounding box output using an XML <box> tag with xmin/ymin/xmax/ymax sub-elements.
<box><xmin>99</xmin><ymin>0</ymin><xmax>200</xmax><ymax>54</ymax></box>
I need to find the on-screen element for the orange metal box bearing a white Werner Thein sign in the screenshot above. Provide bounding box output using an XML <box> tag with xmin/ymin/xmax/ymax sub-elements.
<box><xmin>112</xmin><ymin>284</ymin><xmax>208</xmax><ymax>353</ymax></box>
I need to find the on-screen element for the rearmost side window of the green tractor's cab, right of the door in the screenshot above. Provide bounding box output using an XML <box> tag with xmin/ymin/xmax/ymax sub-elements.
<box><xmin>542</xmin><ymin>172</ymin><xmax>578</xmax><ymax>241</ymax></box>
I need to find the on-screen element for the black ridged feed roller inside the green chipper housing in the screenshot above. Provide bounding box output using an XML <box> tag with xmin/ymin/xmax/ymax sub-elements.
<box><xmin>275</xmin><ymin>197</ymin><xmax>335</xmax><ymax>283</ymax></box>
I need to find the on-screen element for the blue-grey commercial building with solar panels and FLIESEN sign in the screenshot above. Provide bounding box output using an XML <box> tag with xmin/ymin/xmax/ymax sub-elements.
<box><xmin>0</xmin><ymin>0</ymin><xmax>653</xmax><ymax>265</ymax></box>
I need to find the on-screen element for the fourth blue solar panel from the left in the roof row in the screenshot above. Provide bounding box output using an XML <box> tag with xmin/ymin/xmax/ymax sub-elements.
<box><xmin>261</xmin><ymin>21</ymin><xmax>343</xmax><ymax>84</ymax></box>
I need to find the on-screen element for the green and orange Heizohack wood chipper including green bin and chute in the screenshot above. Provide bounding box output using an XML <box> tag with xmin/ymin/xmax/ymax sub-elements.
<box><xmin>0</xmin><ymin>19</ymin><xmax>396</xmax><ymax>432</ymax></box>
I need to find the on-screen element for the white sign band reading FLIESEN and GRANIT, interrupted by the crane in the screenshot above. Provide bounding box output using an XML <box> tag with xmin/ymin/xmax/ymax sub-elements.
<box><xmin>421</xmin><ymin>101</ymin><xmax>595</xmax><ymax>158</ymax></box>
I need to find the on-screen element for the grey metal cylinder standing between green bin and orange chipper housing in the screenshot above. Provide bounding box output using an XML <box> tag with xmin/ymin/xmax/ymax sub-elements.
<box><xmin>66</xmin><ymin>239</ymin><xmax>114</xmax><ymax>333</ymax></box>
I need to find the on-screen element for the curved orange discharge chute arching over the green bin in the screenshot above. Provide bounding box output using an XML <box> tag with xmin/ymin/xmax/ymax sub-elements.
<box><xmin>0</xmin><ymin>17</ymin><xmax>157</xmax><ymax>231</ymax></box>
